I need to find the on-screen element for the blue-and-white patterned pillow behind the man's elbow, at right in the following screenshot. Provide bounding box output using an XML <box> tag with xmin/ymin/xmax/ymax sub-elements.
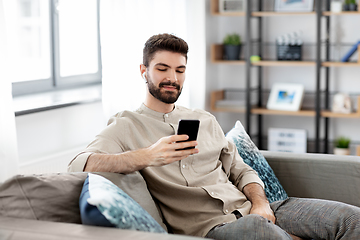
<box><xmin>226</xmin><ymin>121</ymin><xmax>288</xmax><ymax>203</ymax></box>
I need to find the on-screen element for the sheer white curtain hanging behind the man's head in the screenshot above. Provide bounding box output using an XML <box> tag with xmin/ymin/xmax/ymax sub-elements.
<box><xmin>100</xmin><ymin>0</ymin><xmax>206</xmax><ymax>117</ymax></box>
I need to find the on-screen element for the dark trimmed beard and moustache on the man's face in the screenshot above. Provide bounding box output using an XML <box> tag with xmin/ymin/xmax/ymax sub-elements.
<box><xmin>148</xmin><ymin>77</ymin><xmax>182</xmax><ymax>104</ymax></box>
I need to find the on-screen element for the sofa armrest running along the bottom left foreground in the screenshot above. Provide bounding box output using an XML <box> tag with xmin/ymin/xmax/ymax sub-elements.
<box><xmin>0</xmin><ymin>216</ymin><xmax>202</xmax><ymax>240</ymax></box>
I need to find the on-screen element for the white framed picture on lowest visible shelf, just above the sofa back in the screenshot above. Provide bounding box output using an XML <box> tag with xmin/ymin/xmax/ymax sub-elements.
<box><xmin>268</xmin><ymin>128</ymin><xmax>307</xmax><ymax>153</ymax></box>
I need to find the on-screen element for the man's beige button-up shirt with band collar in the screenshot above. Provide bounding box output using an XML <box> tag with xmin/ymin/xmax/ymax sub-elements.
<box><xmin>69</xmin><ymin>105</ymin><xmax>264</xmax><ymax>237</ymax></box>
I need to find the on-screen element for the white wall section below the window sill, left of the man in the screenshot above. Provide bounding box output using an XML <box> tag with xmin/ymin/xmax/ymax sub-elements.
<box><xmin>16</xmin><ymin>102</ymin><xmax>107</xmax><ymax>173</ymax></box>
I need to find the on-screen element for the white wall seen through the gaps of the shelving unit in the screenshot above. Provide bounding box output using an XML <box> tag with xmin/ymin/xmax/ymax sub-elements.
<box><xmin>206</xmin><ymin>3</ymin><xmax>360</xmax><ymax>153</ymax></box>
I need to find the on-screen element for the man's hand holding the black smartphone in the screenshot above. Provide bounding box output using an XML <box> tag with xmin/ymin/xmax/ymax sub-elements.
<box><xmin>146</xmin><ymin>135</ymin><xmax>199</xmax><ymax>167</ymax></box>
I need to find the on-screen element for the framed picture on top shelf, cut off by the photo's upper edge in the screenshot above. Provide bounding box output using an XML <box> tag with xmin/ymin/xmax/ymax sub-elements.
<box><xmin>274</xmin><ymin>0</ymin><xmax>314</xmax><ymax>12</ymax></box>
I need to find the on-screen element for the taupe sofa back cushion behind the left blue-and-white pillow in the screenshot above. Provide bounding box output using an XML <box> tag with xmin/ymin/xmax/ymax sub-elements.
<box><xmin>0</xmin><ymin>172</ymin><xmax>166</xmax><ymax>229</ymax></box>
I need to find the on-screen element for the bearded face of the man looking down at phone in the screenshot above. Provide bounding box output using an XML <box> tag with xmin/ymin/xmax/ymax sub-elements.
<box><xmin>146</xmin><ymin>51</ymin><xmax>186</xmax><ymax>104</ymax></box>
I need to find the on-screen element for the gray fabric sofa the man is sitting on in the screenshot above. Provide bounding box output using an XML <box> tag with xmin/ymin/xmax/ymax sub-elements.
<box><xmin>0</xmin><ymin>151</ymin><xmax>360</xmax><ymax>240</ymax></box>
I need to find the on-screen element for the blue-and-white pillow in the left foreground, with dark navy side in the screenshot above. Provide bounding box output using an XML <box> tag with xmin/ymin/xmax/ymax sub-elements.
<box><xmin>79</xmin><ymin>173</ymin><xmax>166</xmax><ymax>233</ymax></box>
